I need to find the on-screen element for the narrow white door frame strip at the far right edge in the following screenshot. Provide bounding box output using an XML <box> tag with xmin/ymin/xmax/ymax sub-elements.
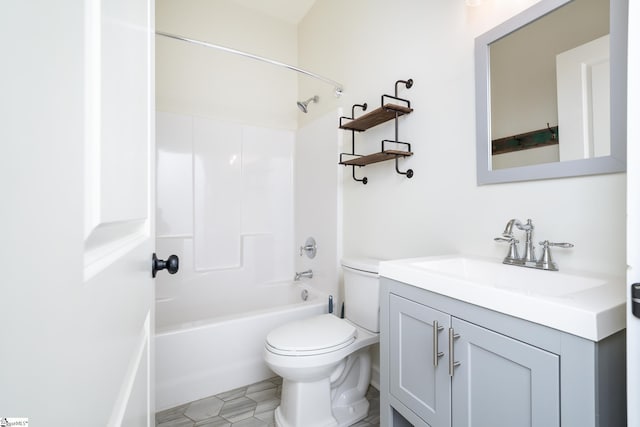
<box><xmin>627</xmin><ymin>2</ymin><xmax>640</xmax><ymax>427</ymax></box>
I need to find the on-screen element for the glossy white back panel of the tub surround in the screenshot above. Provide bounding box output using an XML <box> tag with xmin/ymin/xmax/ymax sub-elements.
<box><xmin>157</xmin><ymin>112</ymin><xmax>294</xmax><ymax>281</ymax></box>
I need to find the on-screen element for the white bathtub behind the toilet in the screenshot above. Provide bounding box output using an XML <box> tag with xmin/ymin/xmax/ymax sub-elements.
<box><xmin>155</xmin><ymin>282</ymin><xmax>328</xmax><ymax>411</ymax></box>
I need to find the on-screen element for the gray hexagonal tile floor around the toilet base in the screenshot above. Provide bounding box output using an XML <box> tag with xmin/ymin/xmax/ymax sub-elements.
<box><xmin>156</xmin><ymin>377</ymin><xmax>380</xmax><ymax>427</ymax></box>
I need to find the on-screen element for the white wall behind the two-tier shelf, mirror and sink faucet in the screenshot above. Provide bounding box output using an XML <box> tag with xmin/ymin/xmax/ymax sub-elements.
<box><xmin>296</xmin><ymin>0</ymin><xmax>626</xmax><ymax>275</ymax></box>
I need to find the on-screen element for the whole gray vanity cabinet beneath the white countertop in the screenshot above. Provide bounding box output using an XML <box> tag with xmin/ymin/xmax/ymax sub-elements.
<box><xmin>380</xmin><ymin>277</ymin><xmax>626</xmax><ymax>427</ymax></box>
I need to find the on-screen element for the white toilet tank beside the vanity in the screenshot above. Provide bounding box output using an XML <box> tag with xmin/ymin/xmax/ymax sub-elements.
<box><xmin>342</xmin><ymin>258</ymin><xmax>380</xmax><ymax>333</ymax></box>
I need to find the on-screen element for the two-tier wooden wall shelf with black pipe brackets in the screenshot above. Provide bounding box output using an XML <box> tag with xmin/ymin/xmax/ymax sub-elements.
<box><xmin>338</xmin><ymin>79</ymin><xmax>413</xmax><ymax>184</ymax></box>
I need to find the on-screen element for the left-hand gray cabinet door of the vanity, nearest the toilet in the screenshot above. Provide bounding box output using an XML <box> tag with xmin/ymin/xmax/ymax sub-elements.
<box><xmin>389</xmin><ymin>295</ymin><xmax>451</xmax><ymax>427</ymax></box>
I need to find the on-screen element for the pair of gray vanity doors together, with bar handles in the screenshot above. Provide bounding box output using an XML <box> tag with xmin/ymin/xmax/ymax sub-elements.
<box><xmin>389</xmin><ymin>295</ymin><xmax>560</xmax><ymax>427</ymax></box>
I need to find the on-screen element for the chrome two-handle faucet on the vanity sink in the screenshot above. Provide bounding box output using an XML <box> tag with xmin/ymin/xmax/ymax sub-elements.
<box><xmin>494</xmin><ymin>219</ymin><xmax>573</xmax><ymax>271</ymax></box>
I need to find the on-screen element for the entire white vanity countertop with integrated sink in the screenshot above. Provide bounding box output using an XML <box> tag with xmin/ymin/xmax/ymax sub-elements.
<box><xmin>380</xmin><ymin>255</ymin><xmax>626</xmax><ymax>341</ymax></box>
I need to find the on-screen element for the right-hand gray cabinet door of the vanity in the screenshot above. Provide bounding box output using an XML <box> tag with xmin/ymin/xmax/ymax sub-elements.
<box><xmin>451</xmin><ymin>317</ymin><xmax>560</xmax><ymax>427</ymax></box>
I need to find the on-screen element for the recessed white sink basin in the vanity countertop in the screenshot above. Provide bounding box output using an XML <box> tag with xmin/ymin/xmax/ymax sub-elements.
<box><xmin>413</xmin><ymin>256</ymin><xmax>606</xmax><ymax>297</ymax></box>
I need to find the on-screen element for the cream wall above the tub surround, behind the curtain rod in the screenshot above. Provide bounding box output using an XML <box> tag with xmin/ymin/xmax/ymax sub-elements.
<box><xmin>156</xmin><ymin>0</ymin><xmax>298</xmax><ymax>129</ymax></box>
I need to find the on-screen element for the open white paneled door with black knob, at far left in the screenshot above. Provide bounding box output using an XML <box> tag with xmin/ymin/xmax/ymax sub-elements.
<box><xmin>0</xmin><ymin>0</ymin><xmax>155</xmax><ymax>426</ymax></box>
